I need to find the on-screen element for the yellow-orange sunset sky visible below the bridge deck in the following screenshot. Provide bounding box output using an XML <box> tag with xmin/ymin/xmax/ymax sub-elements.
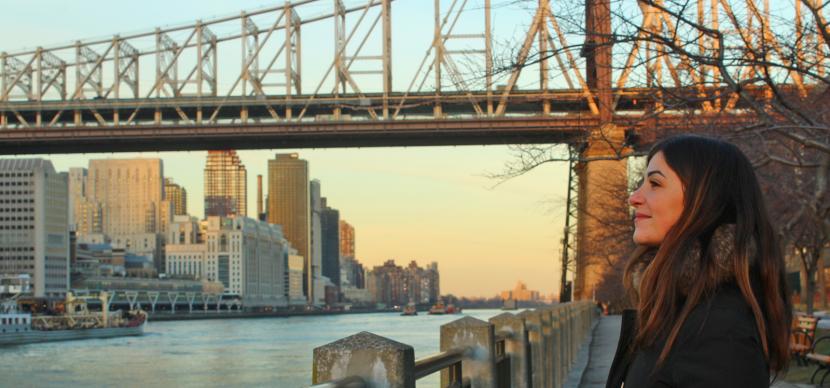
<box><xmin>27</xmin><ymin>146</ymin><xmax>567</xmax><ymax>297</ymax></box>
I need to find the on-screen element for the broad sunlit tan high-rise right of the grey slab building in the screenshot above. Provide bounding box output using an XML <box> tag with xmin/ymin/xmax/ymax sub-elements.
<box><xmin>84</xmin><ymin>159</ymin><xmax>172</xmax><ymax>272</ymax></box>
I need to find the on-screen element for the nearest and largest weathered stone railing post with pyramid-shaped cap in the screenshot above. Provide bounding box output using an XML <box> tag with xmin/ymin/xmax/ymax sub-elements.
<box><xmin>312</xmin><ymin>331</ymin><xmax>415</xmax><ymax>388</ymax></box>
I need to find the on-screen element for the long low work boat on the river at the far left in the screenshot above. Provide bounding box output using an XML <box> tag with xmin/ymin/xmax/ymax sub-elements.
<box><xmin>0</xmin><ymin>275</ymin><xmax>147</xmax><ymax>346</ymax></box>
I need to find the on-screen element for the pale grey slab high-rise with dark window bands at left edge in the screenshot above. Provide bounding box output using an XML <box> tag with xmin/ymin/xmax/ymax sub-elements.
<box><xmin>0</xmin><ymin>159</ymin><xmax>70</xmax><ymax>298</ymax></box>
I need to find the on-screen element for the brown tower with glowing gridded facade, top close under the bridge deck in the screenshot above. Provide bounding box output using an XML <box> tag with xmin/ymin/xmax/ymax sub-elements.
<box><xmin>205</xmin><ymin>150</ymin><xmax>248</xmax><ymax>217</ymax></box>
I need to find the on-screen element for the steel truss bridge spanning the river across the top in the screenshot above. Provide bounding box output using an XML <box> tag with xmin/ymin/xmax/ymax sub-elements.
<box><xmin>0</xmin><ymin>0</ymin><xmax>824</xmax><ymax>297</ymax></box>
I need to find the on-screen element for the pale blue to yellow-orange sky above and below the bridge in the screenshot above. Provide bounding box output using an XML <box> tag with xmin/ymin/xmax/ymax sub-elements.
<box><xmin>0</xmin><ymin>0</ymin><xmax>567</xmax><ymax>297</ymax></box>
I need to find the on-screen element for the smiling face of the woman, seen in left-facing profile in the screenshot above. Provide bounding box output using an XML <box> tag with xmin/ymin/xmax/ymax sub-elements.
<box><xmin>628</xmin><ymin>152</ymin><xmax>683</xmax><ymax>246</ymax></box>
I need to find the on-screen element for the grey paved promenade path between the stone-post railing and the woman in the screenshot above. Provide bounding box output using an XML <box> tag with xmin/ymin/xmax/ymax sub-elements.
<box><xmin>580</xmin><ymin>315</ymin><xmax>812</xmax><ymax>388</ymax></box>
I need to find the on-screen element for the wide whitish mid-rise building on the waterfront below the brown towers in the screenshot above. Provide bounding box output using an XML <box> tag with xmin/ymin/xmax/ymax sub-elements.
<box><xmin>166</xmin><ymin>216</ymin><xmax>288</xmax><ymax>307</ymax></box>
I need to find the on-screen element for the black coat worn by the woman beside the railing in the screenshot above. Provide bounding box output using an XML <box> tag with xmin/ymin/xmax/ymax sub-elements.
<box><xmin>606</xmin><ymin>283</ymin><xmax>769</xmax><ymax>388</ymax></box>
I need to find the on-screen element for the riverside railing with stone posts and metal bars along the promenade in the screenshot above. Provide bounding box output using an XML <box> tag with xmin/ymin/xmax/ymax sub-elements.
<box><xmin>312</xmin><ymin>302</ymin><xmax>598</xmax><ymax>388</ymax></box>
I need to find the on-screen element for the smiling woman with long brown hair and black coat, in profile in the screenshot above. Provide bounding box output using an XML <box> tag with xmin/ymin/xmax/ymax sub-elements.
<box><xmin>607</xmin><ymin>136</ymin><xmax>792</xmax><ymax>388</ymax></box>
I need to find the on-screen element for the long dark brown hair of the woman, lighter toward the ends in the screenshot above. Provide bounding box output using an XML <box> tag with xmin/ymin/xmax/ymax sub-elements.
<box><xmin>625</xmin><ymin>135</ymin><xmax>792</xmax><ymax>371</ymax></box>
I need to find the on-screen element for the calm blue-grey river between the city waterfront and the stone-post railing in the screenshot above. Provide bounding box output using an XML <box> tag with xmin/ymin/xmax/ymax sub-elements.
<box><xmin>0</xmin><ymin>310</ymin><xmax>502</xmax><ymax>387</ymax></box>
